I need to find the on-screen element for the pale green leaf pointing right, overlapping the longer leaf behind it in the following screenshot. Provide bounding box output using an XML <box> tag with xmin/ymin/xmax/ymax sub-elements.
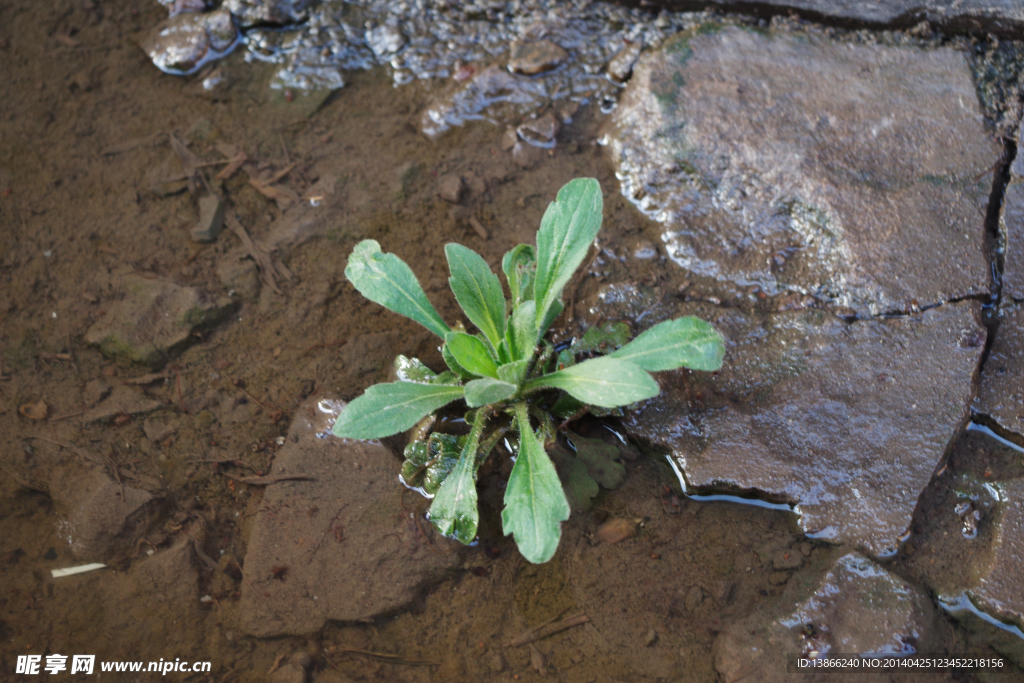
<box><xmin>524</xmin><ymin>356</ymin><xmax>660</xmax><ymax>408</ymax></box>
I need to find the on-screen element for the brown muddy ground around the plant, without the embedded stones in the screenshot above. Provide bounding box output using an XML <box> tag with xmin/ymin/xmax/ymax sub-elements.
<box><xmin>0</xmin><ymin>0</ymin><xmax>1019</xmax><ymax>682</ymax></box>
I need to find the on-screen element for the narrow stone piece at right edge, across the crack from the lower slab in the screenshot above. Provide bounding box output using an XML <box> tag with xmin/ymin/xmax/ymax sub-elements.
<box><xmin>974</xmin><ymin>306</ymin><xmax>1024</xmax><ymax>435</ymax></box>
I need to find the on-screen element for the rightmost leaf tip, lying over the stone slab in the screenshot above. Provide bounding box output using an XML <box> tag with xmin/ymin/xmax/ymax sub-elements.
<box><xmin>610</xmin><ymin>315</ymin><xmax>725</xmax><ymax>372</ymax></box>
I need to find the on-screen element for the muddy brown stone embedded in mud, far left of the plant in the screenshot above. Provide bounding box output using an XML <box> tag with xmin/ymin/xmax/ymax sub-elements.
<box><xmin>85</xmin><ymin>275</ymin><xmax>234</xmax><ymax>368</ymax></box>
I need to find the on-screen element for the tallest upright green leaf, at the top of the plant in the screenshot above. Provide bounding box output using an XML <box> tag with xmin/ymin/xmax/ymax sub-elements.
<box><xmin>534</xmin><ymin>178</ymin><xmax>602</xmax><ymax>334</ymax></box>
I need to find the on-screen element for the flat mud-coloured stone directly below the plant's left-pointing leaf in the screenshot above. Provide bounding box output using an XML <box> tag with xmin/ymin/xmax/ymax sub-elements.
<box><xmin>241</xmin><ymin>399</ymin><xmax>462</xmax><ymax>637</ymax></box>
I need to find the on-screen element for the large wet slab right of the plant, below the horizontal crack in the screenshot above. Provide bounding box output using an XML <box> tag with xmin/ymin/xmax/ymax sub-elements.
<box><xmin>627</xmin><ymin>302</ymin><xmax>985</xmax><ymax>557</ymax></box>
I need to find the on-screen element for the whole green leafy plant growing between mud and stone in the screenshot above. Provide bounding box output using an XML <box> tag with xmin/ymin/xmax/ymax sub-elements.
<box><xmin>334</xmin><ymin>178</ymin><xmax>725</xmax><ymax>563</ymax></box>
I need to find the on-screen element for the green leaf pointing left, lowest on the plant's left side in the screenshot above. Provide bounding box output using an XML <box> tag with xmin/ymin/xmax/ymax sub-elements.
<box><xmin>334</xmin><ymin>382</ymin><xmax>464</xmax><ymax>438</ymax></box>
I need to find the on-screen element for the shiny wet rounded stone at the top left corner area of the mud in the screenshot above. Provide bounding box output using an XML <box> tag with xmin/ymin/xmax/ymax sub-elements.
<box><xmin>139</xmin><ymin>9</ymin><xmax>238</xmax><ymax>75</ymax></box>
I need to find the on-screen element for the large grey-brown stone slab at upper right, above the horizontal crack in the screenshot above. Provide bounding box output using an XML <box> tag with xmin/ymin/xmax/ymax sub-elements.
<box><xmin>605</xmin><ymin>27</ymin><xmax>1000</xmax><ymax>314</ymax></box>
